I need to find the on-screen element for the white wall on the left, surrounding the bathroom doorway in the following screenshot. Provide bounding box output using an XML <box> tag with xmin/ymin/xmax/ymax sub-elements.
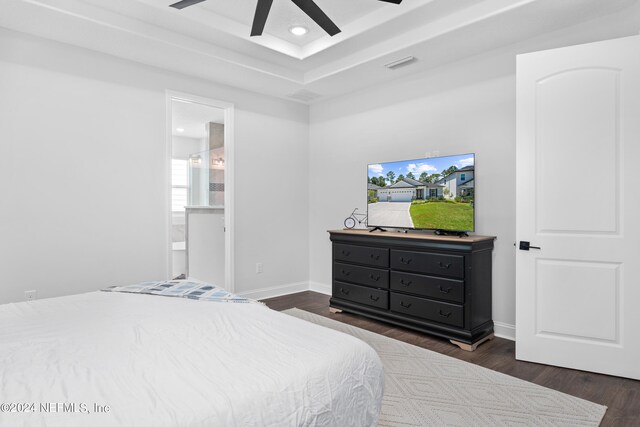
<box><xmin>0</xmin><ymin>29</ymin><xmax>308</xmax><ymax>303</ymax></box>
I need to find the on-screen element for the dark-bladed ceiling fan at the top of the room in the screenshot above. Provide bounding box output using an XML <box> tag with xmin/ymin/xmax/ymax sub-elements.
<box><xmin>169</xmin><ymin>0</ymin><xmax>402</xmax><ymax>37</ymax></box>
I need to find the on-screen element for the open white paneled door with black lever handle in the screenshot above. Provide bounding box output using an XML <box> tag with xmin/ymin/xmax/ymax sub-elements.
<box><xmin>515</xmin><ymin>36</ymin><xmax>640</xmax><ymax>379</ymax></box>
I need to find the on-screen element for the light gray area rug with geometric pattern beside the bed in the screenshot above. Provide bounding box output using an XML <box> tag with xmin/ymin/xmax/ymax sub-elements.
<box><xmin>285</xmin><ymin>308</ymin><xmax>607</xmax><ymax>427</ymax></box>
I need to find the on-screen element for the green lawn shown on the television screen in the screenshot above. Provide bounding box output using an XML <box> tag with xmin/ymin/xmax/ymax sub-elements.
<box><xmin>410</xmin><ymin>201</ymin><xmax>473</xmax><ymax>231</ymax></box>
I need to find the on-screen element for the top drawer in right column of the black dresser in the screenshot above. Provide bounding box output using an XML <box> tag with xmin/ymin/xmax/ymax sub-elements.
<box><xmin>391</xmin><ymin>249</ymin><xmax>464</xmax><ymax>278</ymax></box>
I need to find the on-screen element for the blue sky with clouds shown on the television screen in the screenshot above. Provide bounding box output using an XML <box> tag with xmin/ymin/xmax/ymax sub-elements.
<box><xmin>368</xmin><ymin>154</ymin><xmax>474</xmax><ymax>179</ymax></box>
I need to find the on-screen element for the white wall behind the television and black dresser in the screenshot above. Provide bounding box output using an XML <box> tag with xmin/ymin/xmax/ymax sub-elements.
<box><xmin>309</xmin><ymin>5</ymin><xmax>640</xmax><ymax>337</ymax></box>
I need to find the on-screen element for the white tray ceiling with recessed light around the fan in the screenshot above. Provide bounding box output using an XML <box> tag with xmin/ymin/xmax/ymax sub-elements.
<box><xmin>0</xmin><ymin>0</ymin><xmax>640</xmax><ymax>103</ymax></box>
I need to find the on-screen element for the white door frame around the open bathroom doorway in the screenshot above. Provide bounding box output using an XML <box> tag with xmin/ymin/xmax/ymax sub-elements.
<box><xmin>165</xmin><ymin>90</ymin><xmax>235</xmax><ymax>292</ymax></box>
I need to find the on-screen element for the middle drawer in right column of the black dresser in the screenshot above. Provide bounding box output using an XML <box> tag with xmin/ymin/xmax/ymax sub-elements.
<box><xmin>390</xmin><ymin>271</ymin><xmax>464</xmax><ymax>304</ymax></box>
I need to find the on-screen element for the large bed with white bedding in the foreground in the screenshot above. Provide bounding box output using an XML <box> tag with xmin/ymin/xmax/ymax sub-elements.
<box><xmin>0</xmin><ymin>292</ymin><xmax>383</xmax><ymax>427</ymax></box>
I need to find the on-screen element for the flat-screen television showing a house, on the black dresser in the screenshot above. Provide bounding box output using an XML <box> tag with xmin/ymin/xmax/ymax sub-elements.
<box><xmin>367</xmin><ymin>154</ymin><xmax>475</xmax><ymax>232</ymax></box>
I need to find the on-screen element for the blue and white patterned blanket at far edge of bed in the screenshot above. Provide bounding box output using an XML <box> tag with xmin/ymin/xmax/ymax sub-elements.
<box><xmin>102</xmin><ymin>280</ymin><xmax>258</xmax><ymax>303</ymax></box>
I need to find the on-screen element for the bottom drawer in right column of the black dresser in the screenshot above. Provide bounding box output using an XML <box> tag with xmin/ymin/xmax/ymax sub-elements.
<box><xmin>390</xmin><ymin>292</ymin><xmax>464</xmax><ymax>328</ymax></box>
